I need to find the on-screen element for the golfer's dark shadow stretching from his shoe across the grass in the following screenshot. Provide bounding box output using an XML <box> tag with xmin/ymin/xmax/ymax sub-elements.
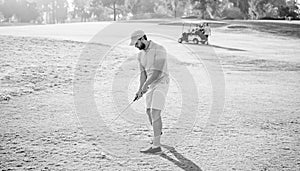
<box><xmin>160</xmin><ymin>145</ymin><xmax>202</xmax><ymax>171</ymax></box>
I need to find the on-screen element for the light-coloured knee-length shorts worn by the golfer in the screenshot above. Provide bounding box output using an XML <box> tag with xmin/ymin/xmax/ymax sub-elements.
<box><xmin>146</xmin><ymin>80</ymin><xmax>169</xmax><ymax>110</ymax></box>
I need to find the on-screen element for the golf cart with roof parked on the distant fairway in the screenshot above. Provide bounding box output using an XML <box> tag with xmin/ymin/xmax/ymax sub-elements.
<box><xmin>178</xmin><ymin>20</ymin><xmax>208</xmax><ymax>44</ymax></box>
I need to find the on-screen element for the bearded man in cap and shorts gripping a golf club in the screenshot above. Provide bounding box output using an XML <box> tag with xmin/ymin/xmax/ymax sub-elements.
<box><xmin>130</xmin><ymin>30</ymin><xmax>169</xmax><ymax>154</ymax></box>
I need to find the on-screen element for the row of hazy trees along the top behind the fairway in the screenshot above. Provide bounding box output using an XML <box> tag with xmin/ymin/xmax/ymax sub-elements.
<box><xmin>0</xmin><ymin>0</ymin><xmax>300</xmax><ymax>23</ymax></box>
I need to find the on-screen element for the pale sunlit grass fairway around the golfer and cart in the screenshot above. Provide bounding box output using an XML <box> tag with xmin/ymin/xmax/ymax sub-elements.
<box><xmin>0</xmin><ymin>21</ymin><xmax>300</xmax><ymax>171</ymax></box>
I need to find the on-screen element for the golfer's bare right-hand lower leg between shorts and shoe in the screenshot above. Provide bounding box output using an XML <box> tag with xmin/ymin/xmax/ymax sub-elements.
<box><xmin>151</xmin><ymin>109</ymin><xmax>162</xmax><ymax>147</ymax></box>
